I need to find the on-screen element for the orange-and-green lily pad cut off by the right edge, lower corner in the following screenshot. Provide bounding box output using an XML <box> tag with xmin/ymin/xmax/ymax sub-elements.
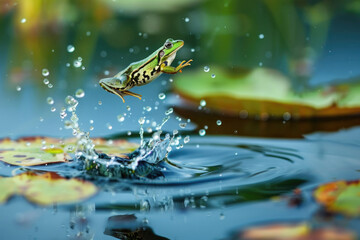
<box><xmin>314</xmin><ymin>180</ymin><xmax>360</xmax><ymax>217</ymax></box>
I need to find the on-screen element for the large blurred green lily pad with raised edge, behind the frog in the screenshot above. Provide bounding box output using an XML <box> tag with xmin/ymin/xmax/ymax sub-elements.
<box><xmin>174</xmin><ymin>67</ymin><xmax>360</xmax><ymax>118</ymax></box>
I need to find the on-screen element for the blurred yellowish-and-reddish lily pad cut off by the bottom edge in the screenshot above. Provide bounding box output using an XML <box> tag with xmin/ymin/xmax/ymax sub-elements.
<box><xmin>237</xmin><ymin>223</ymin><xmax>356</xmax><ymax>240</ymax></box>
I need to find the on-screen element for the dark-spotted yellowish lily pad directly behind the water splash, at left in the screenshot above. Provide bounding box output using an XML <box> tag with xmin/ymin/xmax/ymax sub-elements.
<box><xmin>0</xmin><ymin>137</ymin><xmax>137</xmax><ymax>166</ymax></box>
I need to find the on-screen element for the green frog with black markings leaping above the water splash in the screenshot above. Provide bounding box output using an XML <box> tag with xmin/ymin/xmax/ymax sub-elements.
<box><xmin>99</xmin><ymin>38</ymin><xmax>193</xmax><ymax>103</ymax></box>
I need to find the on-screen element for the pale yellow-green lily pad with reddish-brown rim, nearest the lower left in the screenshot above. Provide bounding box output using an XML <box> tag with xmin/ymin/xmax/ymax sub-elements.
<box><xmin>0</xmin><ymin>172</ymin><xmax>97</xmax><ymax>205</ymax></box>
